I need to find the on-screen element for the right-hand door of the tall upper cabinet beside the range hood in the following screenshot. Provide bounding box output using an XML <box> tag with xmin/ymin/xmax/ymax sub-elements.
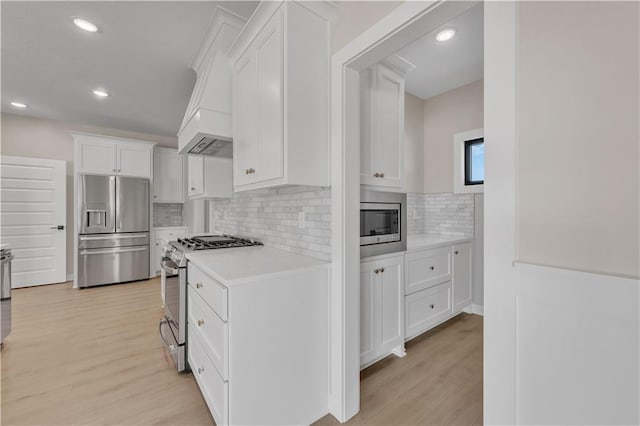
<box><xmin>253</xmin><ymin>8</ymin><xmax>284</xmax><ymax>182</ymax></box>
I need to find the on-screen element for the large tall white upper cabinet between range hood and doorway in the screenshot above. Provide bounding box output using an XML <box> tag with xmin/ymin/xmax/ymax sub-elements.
<box><xmin>230</xmin><ymin>1</ymin><xmax>335</xmax><ymax>191</ymax></box>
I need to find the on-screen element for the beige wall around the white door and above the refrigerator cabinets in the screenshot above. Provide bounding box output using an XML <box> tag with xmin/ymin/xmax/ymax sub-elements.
<box><xmin>0</xmin><ymin>113</ymin><xmax>178</xmax><ymax>276</ymax></box>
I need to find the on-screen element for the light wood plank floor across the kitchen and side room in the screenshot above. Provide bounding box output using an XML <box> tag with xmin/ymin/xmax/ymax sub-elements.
<box><xmin>0</xmin><ymin>279</ymin><xmax>482</xmax><ymax>425</ymax></box>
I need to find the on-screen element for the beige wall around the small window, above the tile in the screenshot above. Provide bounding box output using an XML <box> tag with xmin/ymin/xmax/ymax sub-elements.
<box><xmin>424</xmin><ymin>80</ymin><xmax>484</xmax><ymax>193</ymax></box>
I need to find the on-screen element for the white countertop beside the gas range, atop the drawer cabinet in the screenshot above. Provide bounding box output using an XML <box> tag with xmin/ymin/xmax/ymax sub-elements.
<box><xmin>187</xmin><ymin>246</ymin><xmax>329</xmax><ymax>287</ymax></box>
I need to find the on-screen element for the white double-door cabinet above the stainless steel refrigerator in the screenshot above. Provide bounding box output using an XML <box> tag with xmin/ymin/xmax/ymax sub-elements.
<box><xmin>73</xmin><ymin>133</ymin><xmax>154</xmax><ymax>178</ymax></box>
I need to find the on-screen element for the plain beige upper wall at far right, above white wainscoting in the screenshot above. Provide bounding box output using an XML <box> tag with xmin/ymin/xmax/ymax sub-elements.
<box><xmin>517</xmin><ymin>2</ymin><xmax>640</xmax><ymax>277</ymax></box>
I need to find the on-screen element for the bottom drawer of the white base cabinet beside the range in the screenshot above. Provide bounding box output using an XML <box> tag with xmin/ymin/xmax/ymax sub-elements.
<box><xmin>187</xmin><ymin>334</ymin><xmax>229</xmax><ymax>425</ymax></box>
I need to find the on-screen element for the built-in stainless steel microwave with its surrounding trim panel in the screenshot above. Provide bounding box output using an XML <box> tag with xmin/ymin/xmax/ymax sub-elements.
<box><xmin>360</xmin><ymin>191</ymin><xmax>407</xmax><ymax>257</ymax></box>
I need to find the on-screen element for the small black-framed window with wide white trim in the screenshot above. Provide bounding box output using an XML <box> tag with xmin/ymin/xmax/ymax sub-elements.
<box><xmin>453</xmin><ymin>129</ymin><xmax>484</xmax><ymax>194</ymax></box>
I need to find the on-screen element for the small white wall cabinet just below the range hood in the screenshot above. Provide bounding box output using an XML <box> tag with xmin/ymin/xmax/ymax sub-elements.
<box><xmin>187</xmin><ymin>155</ymin><xmax>233</xmax><ymax>200</ymax></box>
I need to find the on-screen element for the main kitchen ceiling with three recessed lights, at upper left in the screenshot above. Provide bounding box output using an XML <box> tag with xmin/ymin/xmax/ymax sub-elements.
<box><xmin>1</xmin><ymin>1</ymin><xmax>258</xmax><ymax>136</ymax></box>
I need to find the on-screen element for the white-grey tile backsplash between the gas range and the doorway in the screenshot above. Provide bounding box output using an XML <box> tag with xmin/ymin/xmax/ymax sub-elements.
<box><xmin>210</xmin><ymin>186</ymin><xmax>331</xmax><ymax>261</ymax></box>
